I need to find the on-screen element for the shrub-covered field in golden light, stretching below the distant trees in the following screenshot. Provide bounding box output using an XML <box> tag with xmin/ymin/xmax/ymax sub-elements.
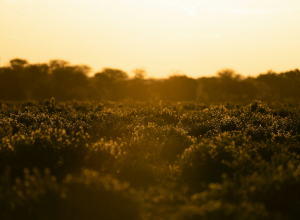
<box><xmin>0</xmin><ymin>98</ymin><xmax>300</xmax><ymax>220</ymax></box>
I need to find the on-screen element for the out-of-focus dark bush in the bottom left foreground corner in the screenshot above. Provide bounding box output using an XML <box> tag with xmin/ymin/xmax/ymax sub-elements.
<box><xmin>0</xmin><ymin>168</ymin><xmax>141</xmax><ymax>220</ymax></box>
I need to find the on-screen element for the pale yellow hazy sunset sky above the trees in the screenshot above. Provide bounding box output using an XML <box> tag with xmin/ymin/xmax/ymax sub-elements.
<box><xmin>0</xmin><ymin>0</ymin><xmax>300</xmax><ymax>77</ymax></box>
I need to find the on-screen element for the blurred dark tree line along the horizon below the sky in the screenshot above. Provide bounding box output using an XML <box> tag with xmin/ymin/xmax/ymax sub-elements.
<box><xmin>0</xmin><ymin>59</ymin><xmax>300</xmax><ymax>102</ymax></box>
